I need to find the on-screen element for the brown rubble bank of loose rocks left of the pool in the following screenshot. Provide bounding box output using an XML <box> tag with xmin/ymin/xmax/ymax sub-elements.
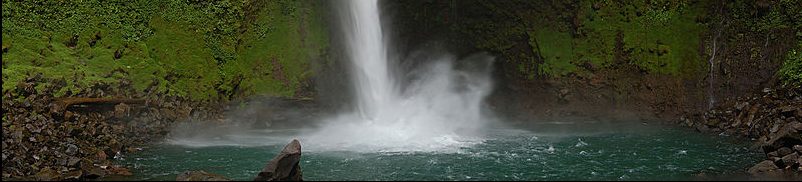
<box><xmin>2</xmin><ymin>75</ymin><xmax>219</xmax><ymax>180</ymax></box>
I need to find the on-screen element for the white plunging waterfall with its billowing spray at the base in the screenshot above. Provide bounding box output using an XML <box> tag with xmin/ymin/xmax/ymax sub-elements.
<box><xmin>302</xmin><ymin>0</ymin><xmax>492</xmax><ymax>152</ymax></box>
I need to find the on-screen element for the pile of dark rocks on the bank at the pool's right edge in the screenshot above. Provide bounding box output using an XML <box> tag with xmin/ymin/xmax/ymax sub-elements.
<box><xmin>679</xmin><ymin>87</ymin><xmax>802</xmax><ymax>177</ymax></box>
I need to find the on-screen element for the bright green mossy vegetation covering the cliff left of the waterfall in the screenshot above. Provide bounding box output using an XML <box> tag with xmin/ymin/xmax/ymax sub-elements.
<box><xmin>2</xmin><ymin>0</ymin><xmax>328</xmax><ymax>101</ymax></box>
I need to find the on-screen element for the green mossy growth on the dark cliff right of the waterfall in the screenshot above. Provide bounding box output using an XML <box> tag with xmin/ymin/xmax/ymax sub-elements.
<box><xmin>404</xmin><ymin>0</ymin><xmax>707</xmax><ymax>79</ymax></box>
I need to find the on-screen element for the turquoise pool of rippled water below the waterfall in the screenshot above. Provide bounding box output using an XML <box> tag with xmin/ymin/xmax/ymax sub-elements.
<box><xmin>119</xmin><ymin>122</ymin><xmax>762</xmax><ymax>180</ymax></box>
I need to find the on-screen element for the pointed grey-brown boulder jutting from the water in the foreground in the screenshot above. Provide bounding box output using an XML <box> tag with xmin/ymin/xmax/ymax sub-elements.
<box><xmin>254</xmin><ymin>139</ymin><xmax>303</xmax><ymax>181</ymax></box>
